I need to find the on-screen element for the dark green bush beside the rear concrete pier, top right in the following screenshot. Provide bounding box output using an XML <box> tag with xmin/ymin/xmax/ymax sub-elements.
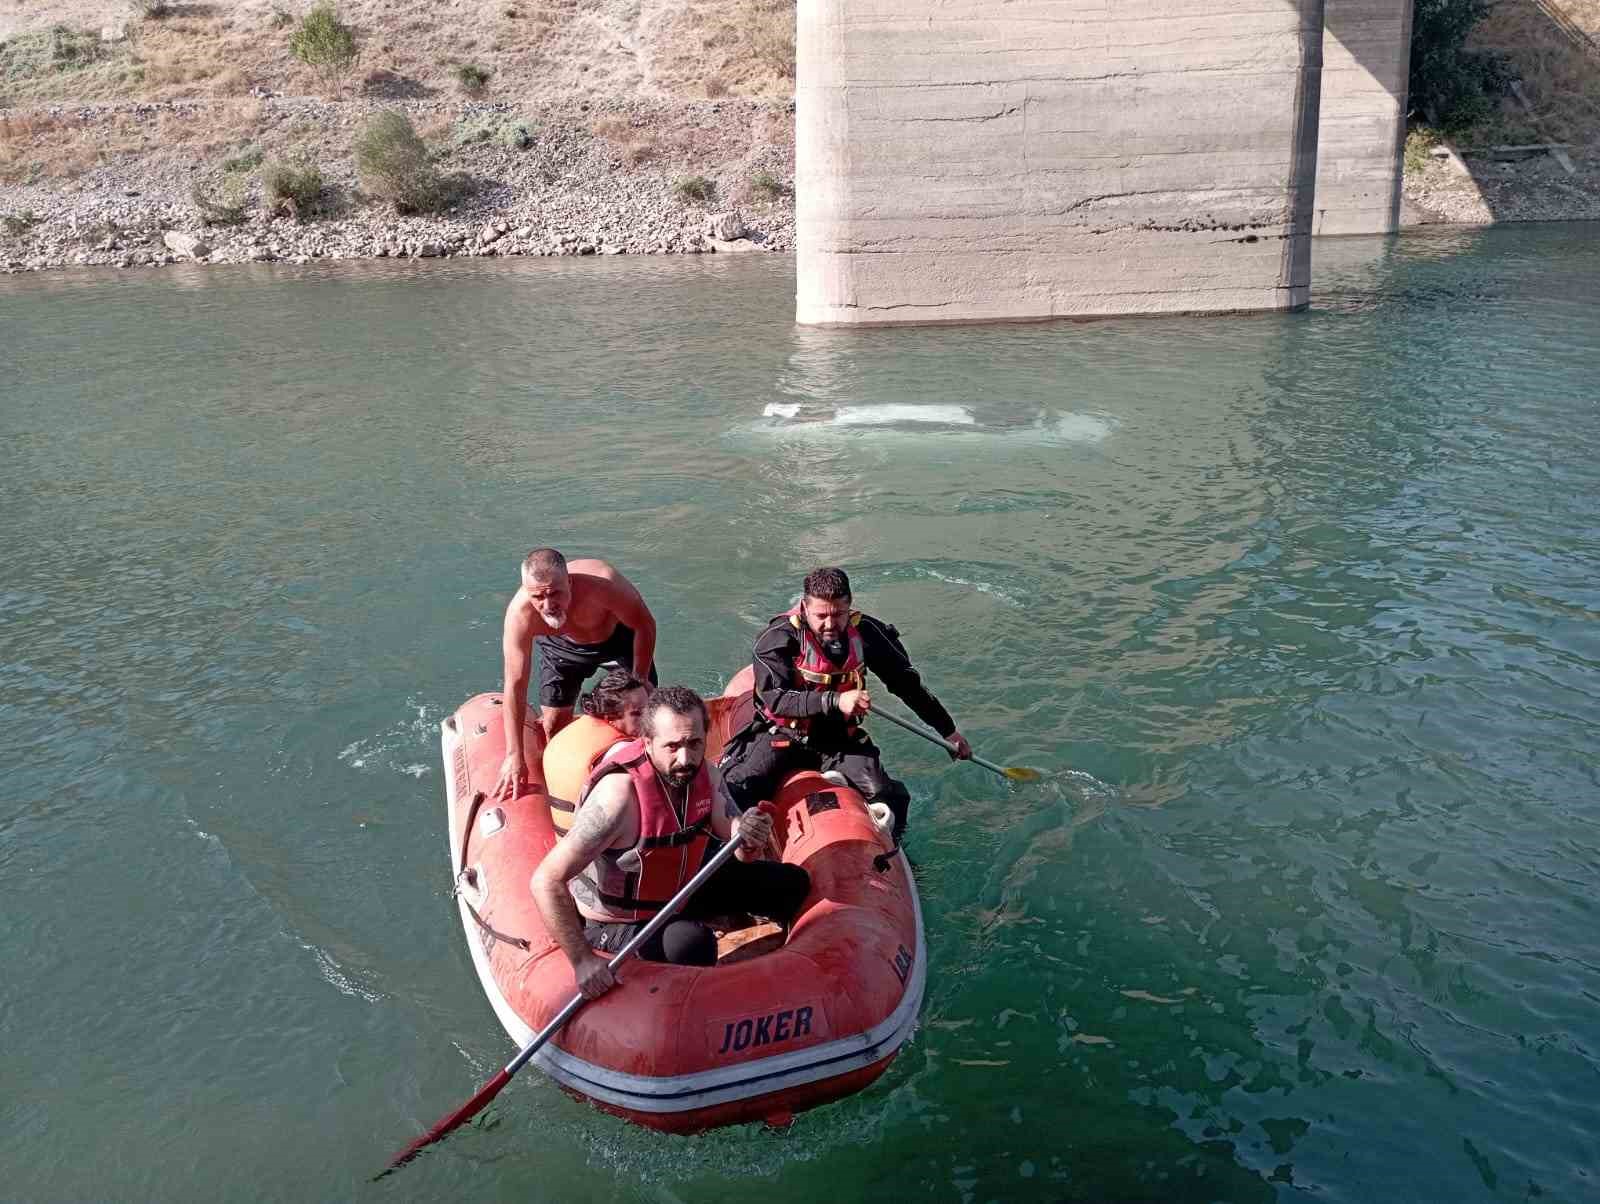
<box><xmin>1411</xmin><ymin>0</ymin><xmax>1517</xmax><ymax>130</ymax></box>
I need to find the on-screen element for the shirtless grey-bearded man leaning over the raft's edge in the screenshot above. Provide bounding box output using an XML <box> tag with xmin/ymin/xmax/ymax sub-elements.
<box><xmin>491</xmin><ymin>548</ymin><xmax>656</xmax><ymax>799</ymax></box>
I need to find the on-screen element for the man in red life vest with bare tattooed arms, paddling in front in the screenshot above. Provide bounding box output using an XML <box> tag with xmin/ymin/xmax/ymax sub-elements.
<box><xmin>530</xmin><ymin>685</ymin><xmax>811</xmax><ymax>999</ymax></box>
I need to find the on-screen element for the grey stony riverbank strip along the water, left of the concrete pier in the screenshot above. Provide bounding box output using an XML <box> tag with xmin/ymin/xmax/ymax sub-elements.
<box><xmin>0</xmin><ymin>96</ymin><xmax>794</xmax><ymax>272</ymax></box>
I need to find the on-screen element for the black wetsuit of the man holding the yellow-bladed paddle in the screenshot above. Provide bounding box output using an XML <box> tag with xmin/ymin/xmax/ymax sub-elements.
<box><xmin>722</xmin><ymin>615</ymin><xmax>955</xmax><ymax>837</ymax></box>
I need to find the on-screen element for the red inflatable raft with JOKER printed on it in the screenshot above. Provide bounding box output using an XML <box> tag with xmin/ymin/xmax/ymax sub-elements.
<box><xmin>443</xmin><ymin>671</ymin><xmax>926</xmax><ymax>1134</ymax></box>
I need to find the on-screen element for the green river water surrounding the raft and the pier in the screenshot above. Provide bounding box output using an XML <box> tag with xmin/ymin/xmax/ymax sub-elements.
<box><xmin>0</xmin><ymin>224</ymin><xmax>1600</xmax><ymax>1202</ymax></box>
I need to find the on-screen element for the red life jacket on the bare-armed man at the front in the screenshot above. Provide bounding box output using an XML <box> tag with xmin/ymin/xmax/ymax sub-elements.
<box><xmin>573</xmin><ymin>740</ymin><xmax>714</xmax><ymax>924</ymax></box>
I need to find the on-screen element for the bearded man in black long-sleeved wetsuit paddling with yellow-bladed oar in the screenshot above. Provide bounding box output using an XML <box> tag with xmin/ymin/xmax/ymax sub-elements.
<box><xmin>722</xmin><ymin>568</ymin><xmax>973</xmax><ymax>839</ymax></box>
